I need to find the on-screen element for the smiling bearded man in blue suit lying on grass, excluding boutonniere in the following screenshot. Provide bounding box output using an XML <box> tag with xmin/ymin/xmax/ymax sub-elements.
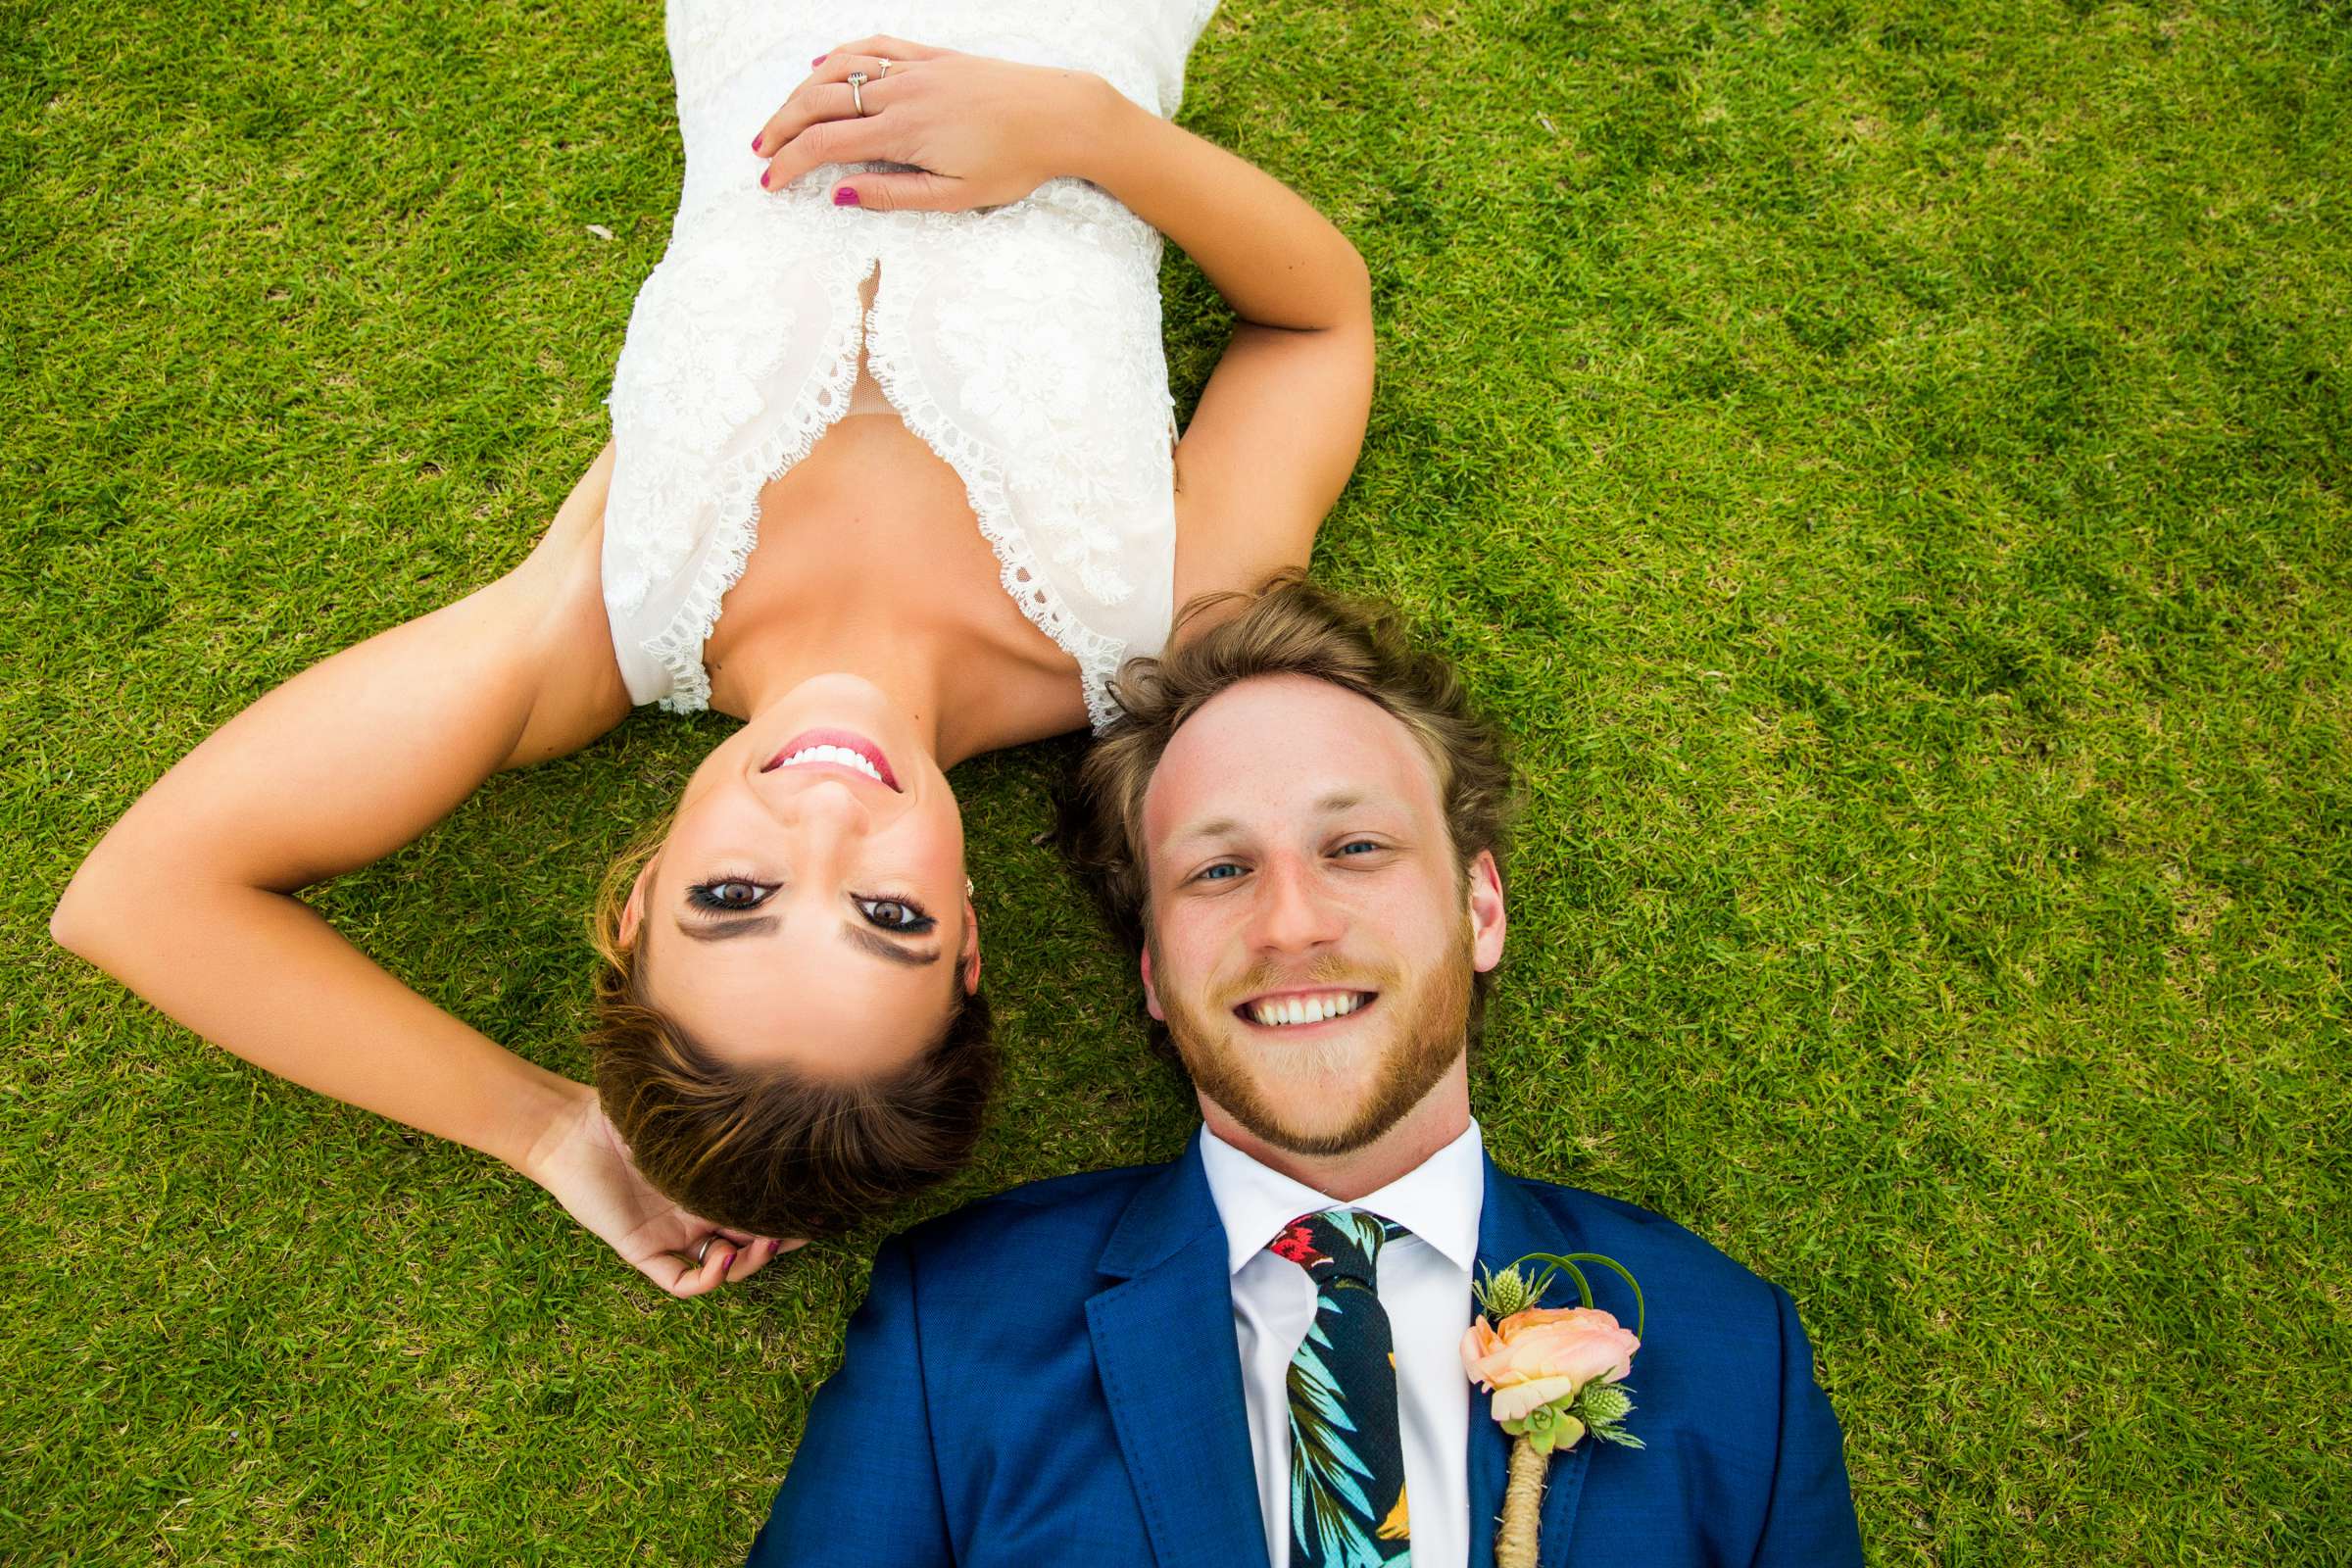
<box><xmin>753</xmin><ymin>583</ymin><xmax>1860</xmax><ymax>1568</ymax></box>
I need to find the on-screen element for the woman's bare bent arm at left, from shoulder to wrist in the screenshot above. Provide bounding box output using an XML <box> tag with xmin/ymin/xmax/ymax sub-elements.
<box><xmin>49</xmin><ymin>449</ymin><xmax>628</xmax><ymax>1203</ymax></box>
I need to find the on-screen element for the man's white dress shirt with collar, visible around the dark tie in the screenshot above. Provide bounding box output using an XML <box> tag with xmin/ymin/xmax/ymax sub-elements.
<box><xmin>1200</xmin><ymin>1121</ymin><xmax>1487</xmax><ymax>1568</ymax></box>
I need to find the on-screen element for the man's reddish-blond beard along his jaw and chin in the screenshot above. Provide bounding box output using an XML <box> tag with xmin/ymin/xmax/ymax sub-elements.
<box><xmin>1152</xmin><ymin>924</ymin><xmax>1472</xmax><ymax>1156</ymax></box>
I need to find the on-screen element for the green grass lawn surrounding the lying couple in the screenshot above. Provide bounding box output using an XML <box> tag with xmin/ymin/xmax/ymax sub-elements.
<box><xmin>0</xmin><ymin>0</ymin><xmax>2352</xmax><ymax>1566</ymax></box>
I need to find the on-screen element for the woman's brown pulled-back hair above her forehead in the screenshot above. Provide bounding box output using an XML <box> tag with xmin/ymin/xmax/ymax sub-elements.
<box><xmin>588</xmin><ymin>823</ymin><xmax>998</xmax><ymax>1239</ymax></box>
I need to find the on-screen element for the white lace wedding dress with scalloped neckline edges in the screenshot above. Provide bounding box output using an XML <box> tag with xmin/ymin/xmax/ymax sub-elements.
<box><xmin>605</xmin><ymin>0</ymin><xmax>1216</xmax><ymax>726</ymax></box>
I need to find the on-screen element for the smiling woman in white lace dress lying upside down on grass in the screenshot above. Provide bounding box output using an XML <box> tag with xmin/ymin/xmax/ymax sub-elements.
<box><xmin>52</xmin><ymin>18</ymin><xmax>1374</xmax><ymax>1296</ymax></box>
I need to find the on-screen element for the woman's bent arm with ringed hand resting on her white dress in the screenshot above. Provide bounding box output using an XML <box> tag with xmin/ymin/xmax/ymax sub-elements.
<box><xmin>755</xmin><ymin>37</ymin><xmax>1374</xmax><ymax>611</ymax></box>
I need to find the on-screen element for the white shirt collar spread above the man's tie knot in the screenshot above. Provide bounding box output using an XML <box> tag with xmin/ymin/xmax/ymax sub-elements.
<box><xmin>1200</xmin><ymin>1119</ymin><xmax>1487</xmax><ymax>1274</ymax></box>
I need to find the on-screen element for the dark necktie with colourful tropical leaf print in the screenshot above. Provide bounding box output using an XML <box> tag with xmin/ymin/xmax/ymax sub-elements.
<box><xmin>1265</xmin><ymin>1208</ymin><xmax>1413</xmax><ymax>1568</ymax></box>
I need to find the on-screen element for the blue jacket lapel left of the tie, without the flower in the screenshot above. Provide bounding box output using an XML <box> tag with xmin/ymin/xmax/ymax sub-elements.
<box><xmin>1087</xmin><ymin>1133</ymin><xmax>1265</xmax><ymax>1568</ymax></box>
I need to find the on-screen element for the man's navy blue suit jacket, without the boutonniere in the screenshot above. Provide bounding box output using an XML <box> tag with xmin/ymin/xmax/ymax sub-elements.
<box><xmin>751</xmin><ymin>1136</ymin><xmax>1860</xmax><ymax>1568</ymax></box>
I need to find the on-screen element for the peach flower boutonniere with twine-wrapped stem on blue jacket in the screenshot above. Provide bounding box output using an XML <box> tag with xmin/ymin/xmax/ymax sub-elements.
<box><xmin>1463</xmin><ymin>1253</ymin><xmax>1648</xmax><ymax>1568</ymax></box>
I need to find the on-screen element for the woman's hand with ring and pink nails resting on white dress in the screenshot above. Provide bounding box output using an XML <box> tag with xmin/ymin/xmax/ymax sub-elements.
<box><xmin>753</xmin><ymin>37</ymin><xmax>1110</xmax><ymax>212</ymax></box>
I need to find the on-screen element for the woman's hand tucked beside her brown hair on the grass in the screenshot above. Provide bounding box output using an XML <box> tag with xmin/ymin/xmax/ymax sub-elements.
<box><xmin>524</xmin><ymin>1086</ymin><xmax>800</xmax><ymax>1296</ymax></box>
